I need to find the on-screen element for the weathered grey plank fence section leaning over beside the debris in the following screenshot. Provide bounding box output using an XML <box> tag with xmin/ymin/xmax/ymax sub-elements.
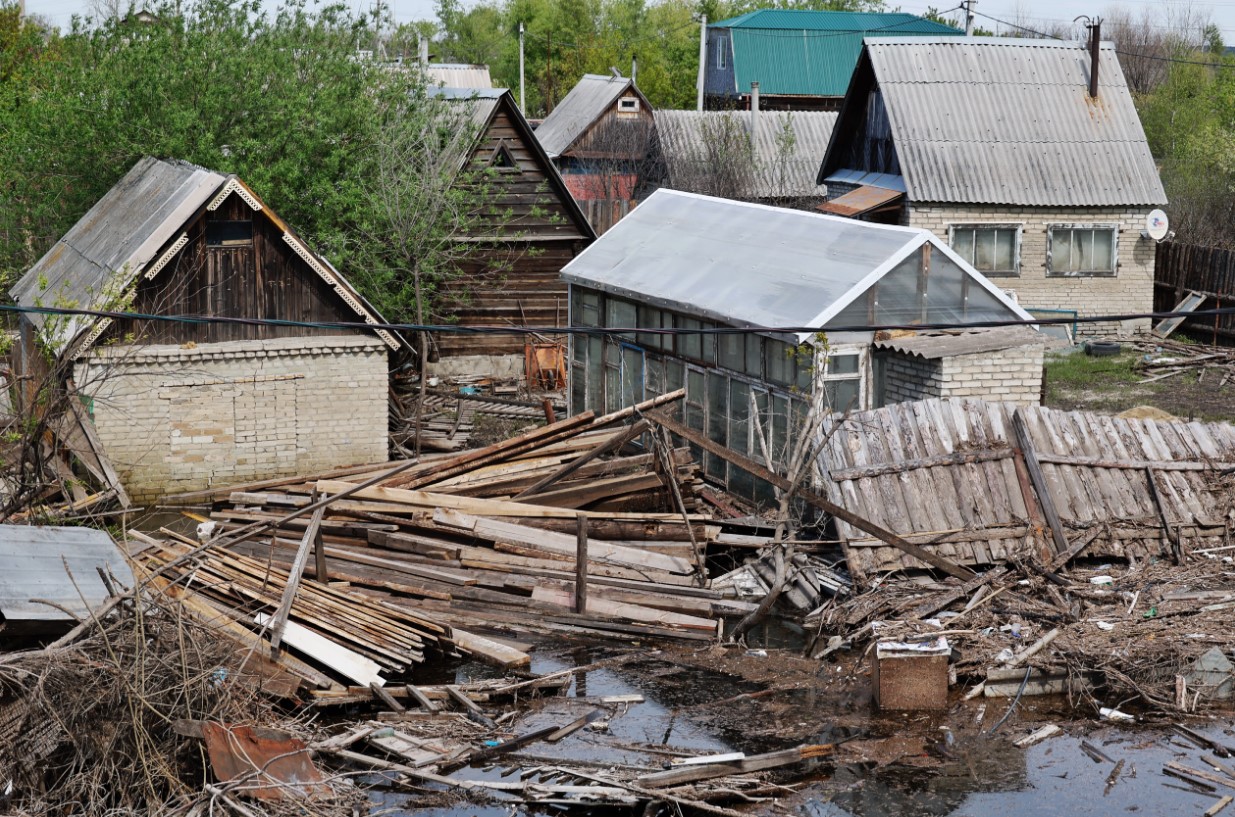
<box><xmin>819</xmin><ymin>400</ymin><xmax>1235</xmax><ymax>574</ymax></box>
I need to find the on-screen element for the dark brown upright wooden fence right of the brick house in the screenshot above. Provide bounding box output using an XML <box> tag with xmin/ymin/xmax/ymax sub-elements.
<box><xmin>1153</xmin><ymin>241</ymin><xmax>1235</xmax><ymax>339</ymax></box>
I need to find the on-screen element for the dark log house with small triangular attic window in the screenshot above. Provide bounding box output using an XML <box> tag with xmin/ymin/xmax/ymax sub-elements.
<box><xmin>431</xmin><ymin>88</ymin><xmax>595</xmax><ymax>376</ymax></box>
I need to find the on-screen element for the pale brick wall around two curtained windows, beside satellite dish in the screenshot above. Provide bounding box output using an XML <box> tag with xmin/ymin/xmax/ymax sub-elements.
<box><xmin>904</xmin><ymin>204</ymin><xmax>1155</xmax><ymax>337</ymax></box>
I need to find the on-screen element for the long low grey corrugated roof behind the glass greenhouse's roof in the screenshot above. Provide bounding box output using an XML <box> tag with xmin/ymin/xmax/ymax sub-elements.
<box><xmin>656</xmin><ymin>111</ymin><xmax>836</xmax><ymax>199</ymax></box>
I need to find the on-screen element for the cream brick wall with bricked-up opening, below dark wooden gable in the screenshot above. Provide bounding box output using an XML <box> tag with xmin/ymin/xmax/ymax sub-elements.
<box><xmin>74</xmin><ymin>336</ymin><xmax>389</xmax><ymax>501</ymax></box>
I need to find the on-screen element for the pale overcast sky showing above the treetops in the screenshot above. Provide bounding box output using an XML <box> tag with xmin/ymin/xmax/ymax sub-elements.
<box><xmin>26</xmin><ymin>0</ymin><xmax>1235</xmax><ymax>44</ymax></box>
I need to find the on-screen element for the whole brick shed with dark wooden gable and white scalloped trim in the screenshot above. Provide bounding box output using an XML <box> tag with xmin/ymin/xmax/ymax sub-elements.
<box><xmin>10</xmin><ymin>157</ymin><xmax>403</xmax><ymax>501</ymax></box>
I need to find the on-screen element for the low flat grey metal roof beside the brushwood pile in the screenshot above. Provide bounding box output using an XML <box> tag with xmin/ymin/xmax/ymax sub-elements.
<box><xmin>0</xmin><ymin>525</ymin><xmax>133</xmax><ymax>622</ymax></box>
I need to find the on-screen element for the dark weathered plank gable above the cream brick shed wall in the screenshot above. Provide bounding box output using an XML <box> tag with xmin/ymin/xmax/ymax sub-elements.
<box><xmin>104</xmin><ymin>194</ymin><xmax>361</xmax><ymax>343</ymax></box>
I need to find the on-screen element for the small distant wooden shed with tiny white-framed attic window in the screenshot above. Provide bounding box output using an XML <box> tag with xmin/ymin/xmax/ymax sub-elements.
<box><xmin>536</xmin><ymin>74</ymin><xmax>655</xmax><ymax>233</ymax></box>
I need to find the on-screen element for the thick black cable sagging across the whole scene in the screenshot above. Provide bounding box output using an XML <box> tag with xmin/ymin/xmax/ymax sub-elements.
<box><xmin>7</xmin><ymin>304</ymin><xmax>1235</xmax><ymax>336</ymax></box>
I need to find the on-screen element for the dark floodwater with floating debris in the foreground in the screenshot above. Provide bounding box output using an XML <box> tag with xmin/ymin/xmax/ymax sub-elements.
<box><xmin>377</xmin><ymin>647</ymin><xmax>1235</xmax><ymax>817</ymax></box>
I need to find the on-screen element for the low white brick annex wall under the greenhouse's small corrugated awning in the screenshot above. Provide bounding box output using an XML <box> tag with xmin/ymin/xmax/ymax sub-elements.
<box><xmin>883</xmin><ymin>343</ymin><xmax>1044</xmax><ymax>406</ymax></box>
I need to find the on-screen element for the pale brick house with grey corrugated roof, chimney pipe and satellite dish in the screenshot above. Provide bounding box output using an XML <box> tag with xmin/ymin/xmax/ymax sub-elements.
<box><xmin>818</xmin><ymin>37</ymin><xmax>1166</xmax><ymax>334</ymax></box>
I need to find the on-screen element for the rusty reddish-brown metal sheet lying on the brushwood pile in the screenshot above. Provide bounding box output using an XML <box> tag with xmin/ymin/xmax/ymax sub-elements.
<box><xmin>201</xmin><ymin>722</ymin><xmax>332</xmax><ymax>800</ymax></box>
